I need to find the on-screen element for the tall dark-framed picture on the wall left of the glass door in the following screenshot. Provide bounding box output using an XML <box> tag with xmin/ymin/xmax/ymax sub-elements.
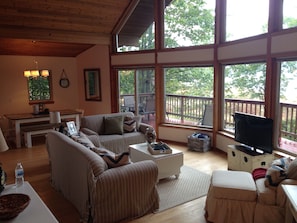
<box><xmin>84</xmin><ymin>68</ymin><xmax>101</xmax><ymax>101</ymax></box>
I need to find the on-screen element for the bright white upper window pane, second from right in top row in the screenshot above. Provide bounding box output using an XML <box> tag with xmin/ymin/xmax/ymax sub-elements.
<box><xmin>226</xmin><ymin>0</ymin><xmax>269</xmax><ymax>41</ymax></box>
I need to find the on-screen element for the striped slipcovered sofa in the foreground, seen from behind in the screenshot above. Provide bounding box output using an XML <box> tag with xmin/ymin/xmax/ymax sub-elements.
<box><xmin>46</xmin><ymin>130</ymin><xmax>159</xmax><ymax>223</ymax></box>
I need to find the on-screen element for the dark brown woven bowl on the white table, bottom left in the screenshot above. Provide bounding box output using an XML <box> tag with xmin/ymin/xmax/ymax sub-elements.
<box><xmin>0</xmin><ymin>194</ymin><xmax>30</xmax><ymax>220</ymax></box>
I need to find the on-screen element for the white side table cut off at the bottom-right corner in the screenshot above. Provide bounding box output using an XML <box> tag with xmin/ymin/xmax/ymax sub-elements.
<box><xmin>282</xmin><ymin>185</ymin><xmax>297</xmax><ymax>223</ymax></box>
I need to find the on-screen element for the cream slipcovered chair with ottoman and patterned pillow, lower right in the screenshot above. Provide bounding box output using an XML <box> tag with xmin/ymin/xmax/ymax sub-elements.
<box><xmin>205</xmin><ymin>158</ymin><xmax>297</xmax><ymax>223</ymax></box>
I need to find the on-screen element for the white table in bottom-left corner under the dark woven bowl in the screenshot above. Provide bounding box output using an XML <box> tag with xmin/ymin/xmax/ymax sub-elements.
<box><xmin>1</xmin><ymin>181</ymin><xmax>58</xmax><ymax>223</ymax></box>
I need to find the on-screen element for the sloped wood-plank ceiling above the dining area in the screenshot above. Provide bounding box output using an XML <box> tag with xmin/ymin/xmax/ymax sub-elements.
<box><xmin>0</xmin><ymin>0</ymin><xmax>132</xmax><ymax>56</ymax></box>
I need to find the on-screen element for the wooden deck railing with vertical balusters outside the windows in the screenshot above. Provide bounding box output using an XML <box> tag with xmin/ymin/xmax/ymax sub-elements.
<box><xmin>121</xmin><ymin>94</ymin><xmax>297</xmax><ymax>141</ymax></box>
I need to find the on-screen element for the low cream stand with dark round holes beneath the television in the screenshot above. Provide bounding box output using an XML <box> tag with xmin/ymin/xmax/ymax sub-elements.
<box><xmin>228</xmin><ymin>145</ymin><xmax>274</xmax><ymax>172</ymax></box>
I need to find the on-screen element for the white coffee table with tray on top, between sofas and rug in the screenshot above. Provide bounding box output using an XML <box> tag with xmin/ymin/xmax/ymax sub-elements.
<box><xmin>129</xmin><ymin>143</ymin><xmax>184</xmax><ymax>180</ymax></box>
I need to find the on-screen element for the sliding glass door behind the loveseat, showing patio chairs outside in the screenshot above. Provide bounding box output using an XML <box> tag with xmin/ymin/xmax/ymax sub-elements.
<box><xmin>118</xmin><ymin>68</ymin><xmax>156</xmax><ymax>126</ymax></box>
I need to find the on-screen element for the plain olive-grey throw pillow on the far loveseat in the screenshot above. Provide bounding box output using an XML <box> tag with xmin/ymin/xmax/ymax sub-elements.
<box><xmin>104</xmin><ymin>116</ymin><xmax>124</xmax><ymax>135</ymax></box>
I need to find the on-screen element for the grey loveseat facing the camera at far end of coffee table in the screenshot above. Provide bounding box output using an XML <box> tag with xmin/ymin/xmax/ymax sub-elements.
<box><xmin>80</xmin><ymin>112</ymin><xmax>153</xmax><ymax>153</ymax></box>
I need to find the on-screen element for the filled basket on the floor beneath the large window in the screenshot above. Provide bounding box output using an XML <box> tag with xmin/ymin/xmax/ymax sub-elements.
<box><xmin>188</xmin><ymin>134</ymin><xmax>210</xmax><ymax>152</ymax></box>
